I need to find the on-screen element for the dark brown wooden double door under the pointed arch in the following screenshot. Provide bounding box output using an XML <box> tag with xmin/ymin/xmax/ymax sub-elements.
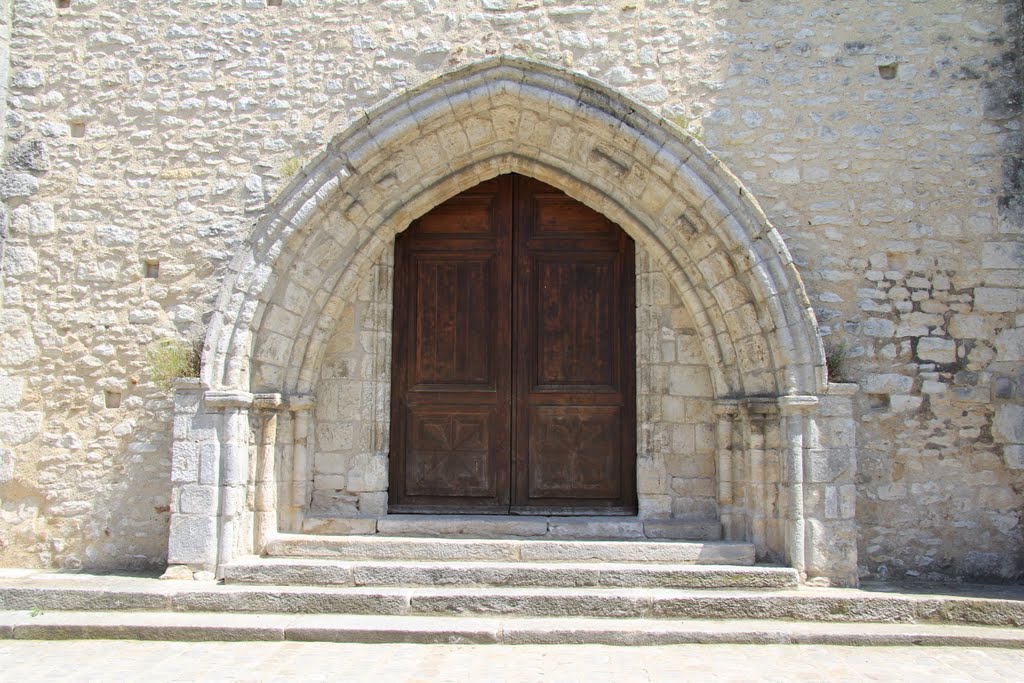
<box><xmin>389</xmin><ymin>175</ymin><xmax>636</xmax><ymax>514</ymax></box>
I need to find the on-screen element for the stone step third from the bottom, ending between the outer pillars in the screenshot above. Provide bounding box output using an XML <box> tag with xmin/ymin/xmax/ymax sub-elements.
<box><xmin>223</xmin><ymin>557</ymin><xmax>800</xmax><ymax>589</ymax></box>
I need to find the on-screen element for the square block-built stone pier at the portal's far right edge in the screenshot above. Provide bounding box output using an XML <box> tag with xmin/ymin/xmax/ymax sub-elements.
<box><xmin>804</xmin><ymin>384</ymin><xmax>859</xmax><ymax>586</ymax></box>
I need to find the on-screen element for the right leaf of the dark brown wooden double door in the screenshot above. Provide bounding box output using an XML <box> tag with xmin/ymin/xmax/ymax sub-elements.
<box><xmin>512</xmin><ymin>178</ymin><xmax>636</xmax><ymax>514</ymax></box>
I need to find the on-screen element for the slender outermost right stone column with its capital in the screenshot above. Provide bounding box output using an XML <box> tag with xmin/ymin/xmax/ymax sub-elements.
<box><xmin>778</xmin><ymin>396</ymin><xmax>818</xmax><ymax>580</ymax></box>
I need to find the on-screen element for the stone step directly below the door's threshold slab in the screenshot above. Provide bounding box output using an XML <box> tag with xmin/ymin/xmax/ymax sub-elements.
<box><xmin>266</xmin><ymin>533</ymin><xmax>754</xmax><ymax>566</ymax></box>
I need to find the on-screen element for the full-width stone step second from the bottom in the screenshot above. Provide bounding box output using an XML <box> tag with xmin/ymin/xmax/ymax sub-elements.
<box><xmin>0</xmin><ymin>571</ymin><xmax>1024</xmax><ymax>628</ymax></box>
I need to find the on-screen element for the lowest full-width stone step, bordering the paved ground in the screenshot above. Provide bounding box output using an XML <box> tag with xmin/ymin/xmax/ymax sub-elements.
<box><xmin>0</xmin><ymin>611</ymin><xmax>1024</xmax><ymax>648</ymax></box>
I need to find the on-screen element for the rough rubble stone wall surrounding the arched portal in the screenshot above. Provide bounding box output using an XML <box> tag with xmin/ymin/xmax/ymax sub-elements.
<box><xmin>0</xmin><ymin>0</ymin><xmax>1024</xmax><ymax>580</ymax></box>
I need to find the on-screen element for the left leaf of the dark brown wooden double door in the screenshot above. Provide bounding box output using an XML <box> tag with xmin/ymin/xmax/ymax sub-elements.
<box><xmin>388</xmin><ymin>179</ymin><xmax>512</xmax><ymax>513</ymax></box>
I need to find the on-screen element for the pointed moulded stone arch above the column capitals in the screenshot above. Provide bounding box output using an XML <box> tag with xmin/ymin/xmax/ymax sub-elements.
<box><xmin>203</xmin><ymin>58</ymin><xmax>825</xmax><ymax>396</ymax></box>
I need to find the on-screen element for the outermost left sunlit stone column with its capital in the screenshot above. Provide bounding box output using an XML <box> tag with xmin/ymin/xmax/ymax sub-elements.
<box><xmin>206</xmin><ymin>389</ymin><xmax>253</xmax><ymax>567</ymax></box>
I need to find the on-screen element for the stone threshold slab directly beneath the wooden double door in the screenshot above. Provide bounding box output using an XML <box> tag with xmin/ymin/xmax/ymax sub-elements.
<box><xmin>302</xmin><ymin>515</ymin><xmax>722</xmax><ymax>541</ymax></box>
